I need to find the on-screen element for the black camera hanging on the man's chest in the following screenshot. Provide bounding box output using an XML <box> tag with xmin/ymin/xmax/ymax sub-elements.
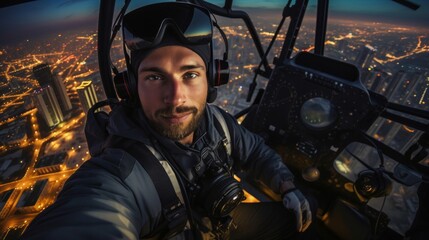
<box><xmin>194</xmin><ymin>147</ymin><xmax>244</xmax><ymax>218</ymax></box>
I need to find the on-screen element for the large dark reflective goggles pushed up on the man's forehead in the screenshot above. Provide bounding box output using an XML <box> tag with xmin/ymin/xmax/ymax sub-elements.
<box><xmin>123</xmin><ymin>2</ymin><xmax>213</xmax><ymax>51</ymax></box>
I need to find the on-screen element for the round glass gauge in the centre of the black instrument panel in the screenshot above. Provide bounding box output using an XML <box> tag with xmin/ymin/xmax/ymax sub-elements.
<box><xmin>300</xmin><ymin>97</ymin><xmax>338</xmax><ymax>130</ymax></box>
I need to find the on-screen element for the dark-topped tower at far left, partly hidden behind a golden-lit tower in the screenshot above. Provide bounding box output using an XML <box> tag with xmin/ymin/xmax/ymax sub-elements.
<box><xmin>33</xmin><ymin>63</ymin><xmax>72</xmax><ymax>113</ymax></box>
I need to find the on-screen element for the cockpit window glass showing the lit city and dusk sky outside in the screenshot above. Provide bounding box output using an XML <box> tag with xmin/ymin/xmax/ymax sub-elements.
<box><xmin>0</xmin><ymin>0</ymin><xmax>429</xmax><ymax>239</ymax></box>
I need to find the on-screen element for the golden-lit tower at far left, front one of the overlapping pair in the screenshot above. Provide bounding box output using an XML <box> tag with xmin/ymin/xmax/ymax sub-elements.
<box><xmin>33</xmin><ymin>85</ymin><xmax>64</xmax><ymax>127</ymax></box>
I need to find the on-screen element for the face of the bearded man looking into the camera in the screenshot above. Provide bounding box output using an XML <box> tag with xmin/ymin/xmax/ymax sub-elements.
<box><xmin>138</xmin><ymin>46</ymin><xmax>208</xmax><ymax>144</ymax></box>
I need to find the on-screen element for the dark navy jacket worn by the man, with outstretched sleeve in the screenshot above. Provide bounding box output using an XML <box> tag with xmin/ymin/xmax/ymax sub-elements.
<box><xmin>23</xmin><ymin>105</ymin><xmax>293</xmax><ymax>240</ymax></box>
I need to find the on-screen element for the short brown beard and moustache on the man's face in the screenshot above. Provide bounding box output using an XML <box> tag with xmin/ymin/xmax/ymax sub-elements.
<box><xmin>149</xmin><ymin>106</ymin><xmax>204</xmax><ymax>141</ymax></box>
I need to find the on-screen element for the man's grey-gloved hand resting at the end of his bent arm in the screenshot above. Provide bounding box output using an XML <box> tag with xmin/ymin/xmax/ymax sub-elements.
<box><xmin>283</xmin><ymin>188</ymin><xmax>312</xmax><ymax>232</ymax></box>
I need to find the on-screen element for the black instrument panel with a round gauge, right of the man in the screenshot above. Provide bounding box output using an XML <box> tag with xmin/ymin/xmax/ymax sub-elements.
<box><xmin>253</xmin><ymin>52</ymin><xmax>375</xmax><ymax>159</ymax></box>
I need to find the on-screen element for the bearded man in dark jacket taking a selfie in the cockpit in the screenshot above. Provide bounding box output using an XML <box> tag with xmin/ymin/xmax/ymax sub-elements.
<box><xmin>23</xmin><ymin>2</ymin><xmax>311</xmax><ymax>239</ymax></box>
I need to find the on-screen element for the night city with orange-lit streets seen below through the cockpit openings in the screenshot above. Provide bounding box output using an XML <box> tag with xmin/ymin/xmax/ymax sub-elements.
<box><xmin>0</xmin><ymin>4</ymin><xmax>429</xmax><ymax>239</ymax></box>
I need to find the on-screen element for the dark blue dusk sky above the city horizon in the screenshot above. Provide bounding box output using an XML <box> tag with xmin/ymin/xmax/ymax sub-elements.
<box><xmin>0</xmin><ymin>0</ymin><xmax>429</xmax><ymax>44</ymax></box>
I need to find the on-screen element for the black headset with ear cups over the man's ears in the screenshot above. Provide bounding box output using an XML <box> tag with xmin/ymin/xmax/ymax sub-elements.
<box><xmin>110</xmin><ymin>4</ymin><xmax>230</xmax><ymax>103</ymax></box>
